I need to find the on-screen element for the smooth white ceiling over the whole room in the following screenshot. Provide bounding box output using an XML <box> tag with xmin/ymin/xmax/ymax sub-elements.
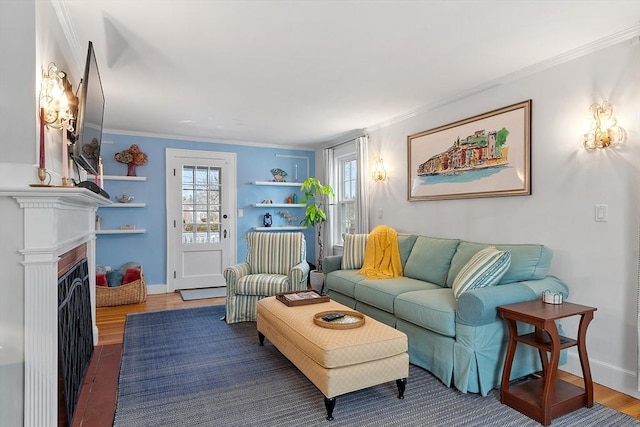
<box><xmin>57</xmin><ymin>0</ymin><xmax>640</xmax><ymax>148</ymax></box>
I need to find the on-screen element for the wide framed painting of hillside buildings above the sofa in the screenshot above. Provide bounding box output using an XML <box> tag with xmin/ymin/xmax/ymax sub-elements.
<box><xmin>407</xmin><ymin>99</ymin><xmax>531</xmax><ymax>201</ymax></box>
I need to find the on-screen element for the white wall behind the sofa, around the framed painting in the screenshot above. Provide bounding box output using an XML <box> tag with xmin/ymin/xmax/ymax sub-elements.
<box><xmin>369</xmin><ymin>38</ymin><xmax>640</xmax><ymax>397</ymax></box>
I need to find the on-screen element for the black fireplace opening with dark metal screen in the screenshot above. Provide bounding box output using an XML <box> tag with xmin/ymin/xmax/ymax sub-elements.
<box><xmin>58</xmin><ymin>258</ymin><xmax>93</xmax><ymax>426</ymax></box>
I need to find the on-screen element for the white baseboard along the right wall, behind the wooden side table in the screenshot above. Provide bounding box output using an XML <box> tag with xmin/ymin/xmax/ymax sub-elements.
<box><xmin>560</xmin><ymin>349</ymin><xmax>640</xmax><ymax>399</ymax></box>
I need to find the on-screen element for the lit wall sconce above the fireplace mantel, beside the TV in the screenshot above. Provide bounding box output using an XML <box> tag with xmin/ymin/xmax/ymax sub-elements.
<box><xmin>40</xmin><ymin>62</ymin><xmax>77</xmax><ymax>131</ymax></box>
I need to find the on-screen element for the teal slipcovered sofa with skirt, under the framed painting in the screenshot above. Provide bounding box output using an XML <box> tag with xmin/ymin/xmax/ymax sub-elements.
<box><xmin>323</xmin><ymin>234</ymin><xmax>569</xmax><ymax>396</ymax></box>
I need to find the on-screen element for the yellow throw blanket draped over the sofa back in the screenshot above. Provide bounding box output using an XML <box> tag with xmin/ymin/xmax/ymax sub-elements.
<box><xmin>358</xmin><ymin>225</ymin><xmax>402</xmax><ymax>279</ymax></box>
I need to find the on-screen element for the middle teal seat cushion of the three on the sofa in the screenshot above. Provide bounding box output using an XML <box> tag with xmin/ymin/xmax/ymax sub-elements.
<box><xmin>354</xmin><ymin>277</ymin><xmax>440</xmax><ymax>313</ymax></box>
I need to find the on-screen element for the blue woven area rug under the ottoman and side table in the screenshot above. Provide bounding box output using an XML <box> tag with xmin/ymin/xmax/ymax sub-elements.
<box><xmin>114</xmin><ymin>306</ymin><xmax>640</xmax><ymax>427</ymax></box>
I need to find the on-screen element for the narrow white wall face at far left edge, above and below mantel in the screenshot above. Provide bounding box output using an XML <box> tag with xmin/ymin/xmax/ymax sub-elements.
<box><xmin>0</xmin><ymin>0</ymin><xmax>37</xmax><ymax>427</ymax></box>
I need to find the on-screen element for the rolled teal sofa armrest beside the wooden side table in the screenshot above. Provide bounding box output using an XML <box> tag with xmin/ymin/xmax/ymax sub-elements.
<box><xmin>456</xmin><ymin>276</ymin><xmax>569</xmax><ymax>326</ymax></box>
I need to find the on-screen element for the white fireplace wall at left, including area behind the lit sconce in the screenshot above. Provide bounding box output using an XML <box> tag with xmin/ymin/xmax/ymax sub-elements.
<box><xmin>0</xmin><ymin>0</ymin><xmax>78</xmax><ymax>427</ymax></box>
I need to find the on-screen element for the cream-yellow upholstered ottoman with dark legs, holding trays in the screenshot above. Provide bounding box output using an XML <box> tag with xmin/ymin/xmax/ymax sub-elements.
<box><xmin>257</xmin><ymin>297</ymin><xmax>409</xmax><ymax>420</ymax></box>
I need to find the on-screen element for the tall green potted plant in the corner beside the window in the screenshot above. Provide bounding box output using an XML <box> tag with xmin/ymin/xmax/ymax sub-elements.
<box><xmin>300</xmin><ymin>177</ymin><xmax>335</xmax><ymax>290</ymax></box>
